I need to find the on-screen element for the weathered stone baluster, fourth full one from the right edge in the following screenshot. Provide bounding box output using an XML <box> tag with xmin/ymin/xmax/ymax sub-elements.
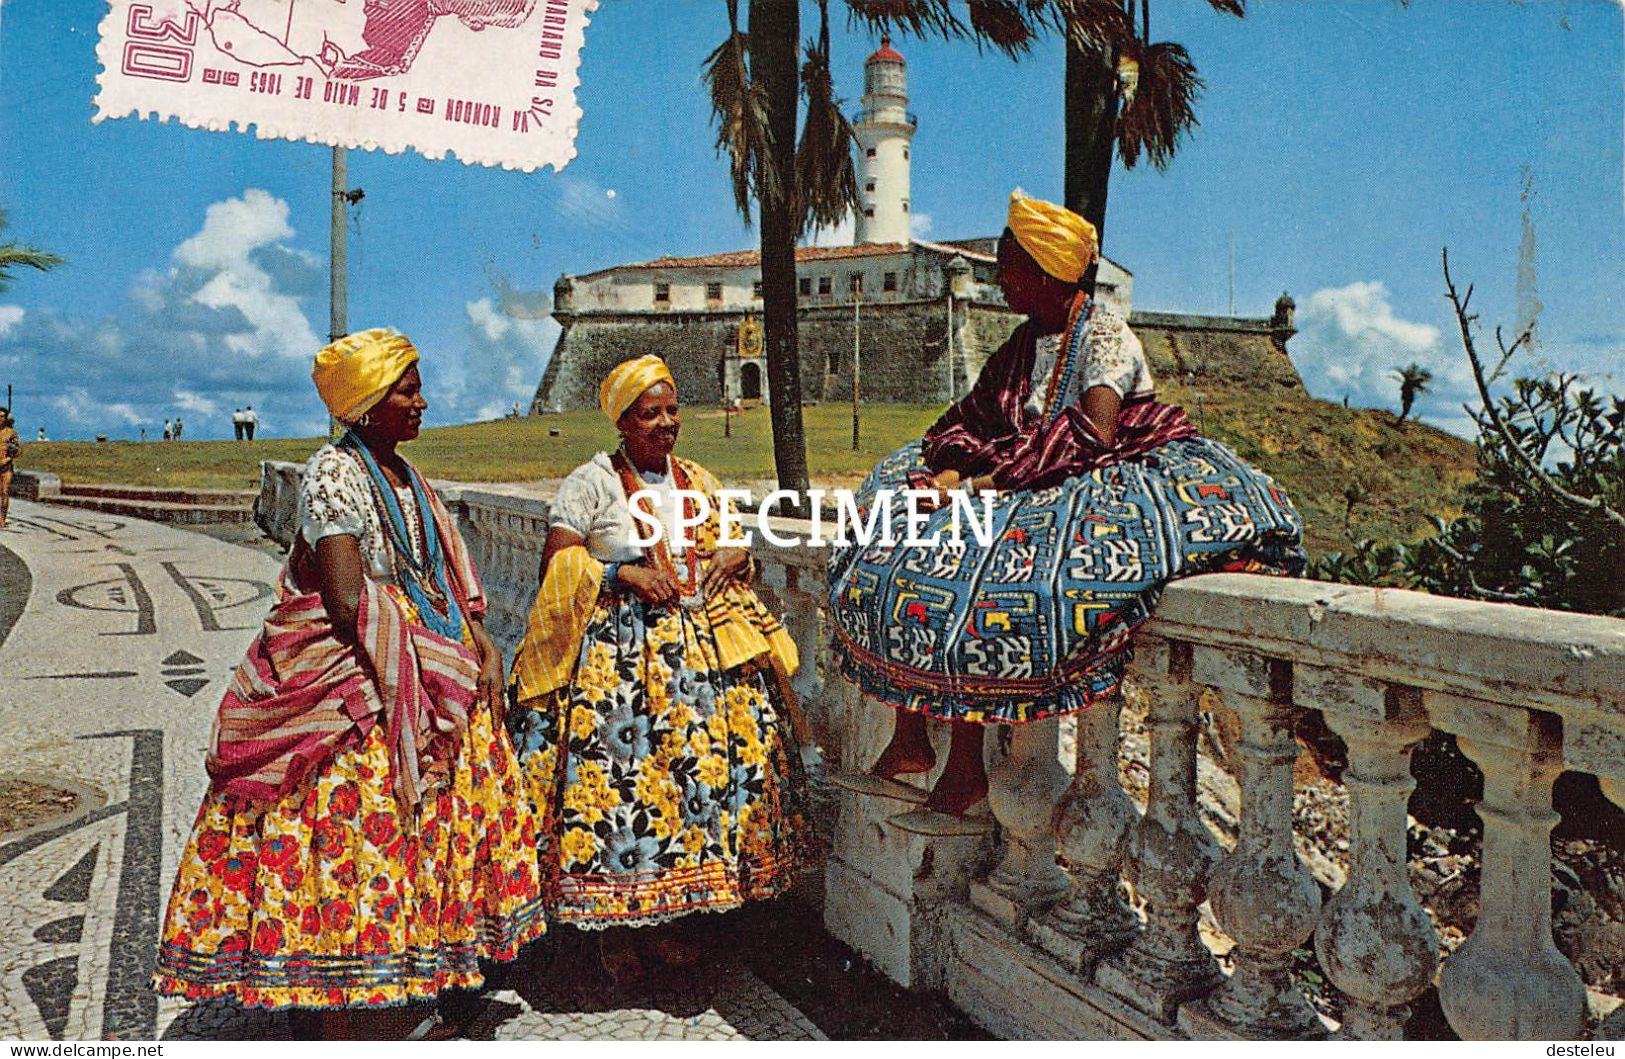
<box><xmin>1095</xmin><ymin>643</ymin><xmax>1224</xmax><ymax>1023</ymax></box>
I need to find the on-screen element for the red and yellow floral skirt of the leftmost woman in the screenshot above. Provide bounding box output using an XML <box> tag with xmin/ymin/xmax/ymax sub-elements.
<box><xmin>153</xmin><ymin>656</ymin><xmax>546</xmax><ymax>1007</ymax></box>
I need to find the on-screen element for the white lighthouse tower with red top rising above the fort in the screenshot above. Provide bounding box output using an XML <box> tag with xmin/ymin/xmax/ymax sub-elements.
<box><xmin>852</xmin><ymin>37</ymin><xmax>915</xmax><ymax>244</ymax></box>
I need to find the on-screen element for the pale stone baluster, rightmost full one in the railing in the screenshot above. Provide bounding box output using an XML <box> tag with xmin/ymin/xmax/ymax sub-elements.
<box><xmin>1425</xmin><ymin>694</ymin><xmax>1586</xmax><ymax>1041</ymax></box>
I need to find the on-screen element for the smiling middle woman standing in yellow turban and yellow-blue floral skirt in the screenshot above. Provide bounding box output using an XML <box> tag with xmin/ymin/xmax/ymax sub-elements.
<box><xmin>509</xmin><ymin>356</ymin><xmax>803</xmax><ymax>981</ymax></box>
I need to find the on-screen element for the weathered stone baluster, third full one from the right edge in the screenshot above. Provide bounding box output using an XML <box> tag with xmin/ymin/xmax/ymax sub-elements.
<box><xmin>1180</xmin><ymin>648</ymin><xmax>1326</xmax><ymax>1040</ymax></box>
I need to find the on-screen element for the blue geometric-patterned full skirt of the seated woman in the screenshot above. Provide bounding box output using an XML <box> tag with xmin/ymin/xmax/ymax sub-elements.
<box><xmin>829</xmin><ymin>437</ymin><xmax>1305</xmax><ymax>723</ymax></box>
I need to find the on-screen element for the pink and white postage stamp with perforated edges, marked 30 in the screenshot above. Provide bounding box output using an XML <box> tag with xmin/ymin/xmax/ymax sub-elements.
<box><xmin>94</xmin><ymin>0</ymin><xmax>598</xmax><ymax>172</ymax></box>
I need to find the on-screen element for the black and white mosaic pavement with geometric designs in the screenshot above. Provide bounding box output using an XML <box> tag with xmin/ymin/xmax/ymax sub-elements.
<box><xmin>0</xmin><ymin>500</ymin><xmax>822</xmax><ymax>1040</ymax></box>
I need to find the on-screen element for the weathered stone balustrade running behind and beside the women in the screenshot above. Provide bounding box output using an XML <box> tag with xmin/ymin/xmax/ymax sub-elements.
<box><xmin>258</xmin><ymin>465</ymin><xmax>1625</xmax><ymax>1040</ymax></box>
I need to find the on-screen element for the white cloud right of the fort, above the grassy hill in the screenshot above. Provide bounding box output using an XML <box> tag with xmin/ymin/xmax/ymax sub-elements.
<box><xmin>1292</xmin><ymin>281</ymin><xmax>1474</xmax><ymax>435</ymax></box>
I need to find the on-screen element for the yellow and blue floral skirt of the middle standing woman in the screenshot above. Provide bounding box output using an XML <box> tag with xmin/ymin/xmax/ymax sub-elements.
<box><xmin>509</xmin><ymin>593</ymin><xmax>804</xmax><ymax>929</ymax></box>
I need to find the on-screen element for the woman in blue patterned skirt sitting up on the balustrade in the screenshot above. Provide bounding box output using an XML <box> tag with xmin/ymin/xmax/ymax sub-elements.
<box><xmin>829</xmin><ymin>192</ymin><xmax>1303</xmax><ymax>815</ymax></box>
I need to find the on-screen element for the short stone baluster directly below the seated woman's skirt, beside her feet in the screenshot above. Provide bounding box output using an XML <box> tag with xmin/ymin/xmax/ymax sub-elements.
<box><xmin>972</xmin><ymin>716</ymin><xmax>1068</xmax><ymax>929</ymax></box>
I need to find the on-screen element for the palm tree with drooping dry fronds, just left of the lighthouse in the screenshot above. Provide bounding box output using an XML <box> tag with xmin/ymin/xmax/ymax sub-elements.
<box><xmin>705</xmin><ymin>0</ymin><xmax>858</xmax><ymax>495</ymax></box>
